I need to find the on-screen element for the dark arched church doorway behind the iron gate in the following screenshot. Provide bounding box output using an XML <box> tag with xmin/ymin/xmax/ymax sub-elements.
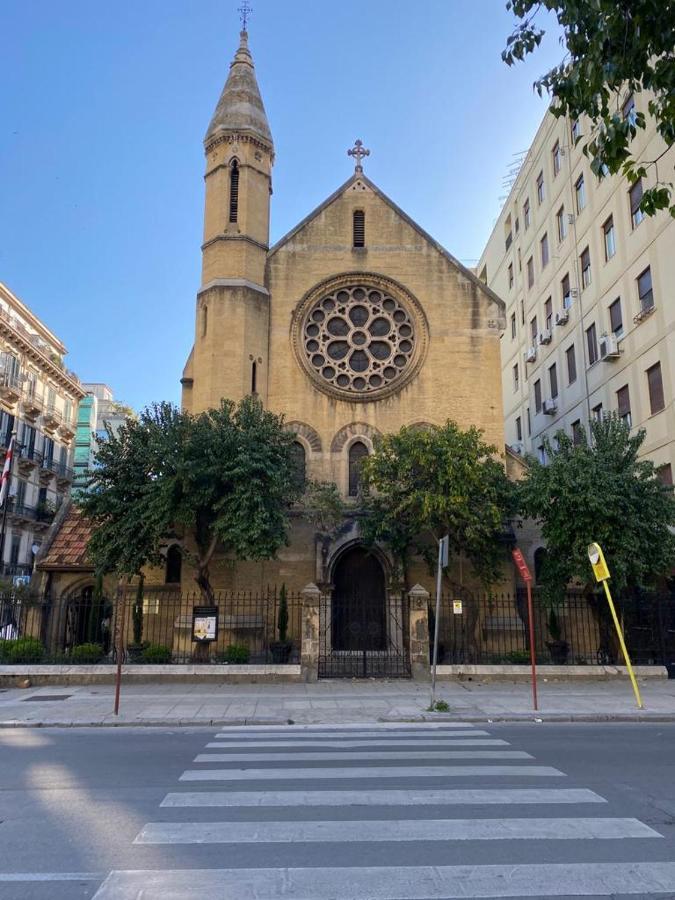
<box><xmin>332</xmin><ymin>547</ymin><xmax>386</xmax><ymax>650</ymax></box>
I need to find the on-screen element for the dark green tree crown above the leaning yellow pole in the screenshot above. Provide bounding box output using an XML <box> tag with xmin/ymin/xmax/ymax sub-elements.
<box><xmin>519</xmin><ymin>416</ymin><xmax>675</xmax><ymax>602</ymax></box>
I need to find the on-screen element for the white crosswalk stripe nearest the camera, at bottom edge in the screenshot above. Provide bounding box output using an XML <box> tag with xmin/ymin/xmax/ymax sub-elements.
<box><xmin>94</xmin><ymin>862</ymin><xmax>675</xmax><ymax>900</ymax></box>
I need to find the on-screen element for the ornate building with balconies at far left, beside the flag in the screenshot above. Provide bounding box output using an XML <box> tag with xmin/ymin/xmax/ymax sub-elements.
<box><xmin>0</xmin><ymin>282</ymin><xmax>84</xmax><ymax>578</ymax></box>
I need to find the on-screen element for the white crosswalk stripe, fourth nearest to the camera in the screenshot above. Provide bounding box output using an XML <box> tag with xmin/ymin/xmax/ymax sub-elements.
<box><xmin>178</xmin><ymin>765</ymin><xmax>565</xmax><ymax>781</ymax></box>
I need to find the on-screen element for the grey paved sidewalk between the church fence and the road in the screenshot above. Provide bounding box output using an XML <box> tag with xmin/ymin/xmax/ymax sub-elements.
<box><xmin>0</xmin><ymin>677</ymin><xmax>675</xmax><ymax>727</ymax></box>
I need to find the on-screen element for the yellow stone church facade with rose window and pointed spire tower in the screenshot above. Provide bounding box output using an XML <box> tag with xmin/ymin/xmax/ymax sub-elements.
<box><xmin>182</xmin><ymin>31</ymin><xmax>504</xmax><ymax>592</ymax></box>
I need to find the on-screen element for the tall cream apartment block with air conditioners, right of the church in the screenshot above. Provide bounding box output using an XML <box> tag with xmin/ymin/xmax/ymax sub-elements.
<box><xmin>478</xmin><ymin>93</ymin><xmax>675</xmax><ymax>483</ymax></box>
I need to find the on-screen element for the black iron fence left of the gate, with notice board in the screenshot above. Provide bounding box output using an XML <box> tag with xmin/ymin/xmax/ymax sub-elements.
<box><xmin>0</xmin><ymin>589</ymin><xmax>302</xmax><ymax>664</ymax></box>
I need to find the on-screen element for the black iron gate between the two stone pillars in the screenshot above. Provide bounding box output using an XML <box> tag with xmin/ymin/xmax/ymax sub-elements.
<box><xmin>319</xmin><ymin>592</ymin><xmax>410</xmax><ymax>678</ymax></box>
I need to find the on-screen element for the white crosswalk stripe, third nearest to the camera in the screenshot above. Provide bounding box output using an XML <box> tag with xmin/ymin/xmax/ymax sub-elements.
<box><xmin>160</xmin><ymin>788</ymin><xmax>607</xmax><ymax>808</ymax></box>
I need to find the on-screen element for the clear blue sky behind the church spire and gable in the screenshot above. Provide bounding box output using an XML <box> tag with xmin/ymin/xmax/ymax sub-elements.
<box><xmin>0</xmin><ymin>0</ymin><xmax>561</xmax><ymax>408</ymax></box>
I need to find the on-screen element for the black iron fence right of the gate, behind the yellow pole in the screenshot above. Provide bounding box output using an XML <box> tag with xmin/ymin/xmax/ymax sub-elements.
<box><xmin>429</xmin><ymin>589</ymin><xmax>675</xmax><ymax>670</ymax></box>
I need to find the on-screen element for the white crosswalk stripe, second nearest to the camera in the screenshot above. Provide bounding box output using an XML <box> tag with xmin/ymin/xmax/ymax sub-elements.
<box><xmin>134</xmin><ymin>817</ymin><xmax>661</xmax><ymax>844</ymax></box>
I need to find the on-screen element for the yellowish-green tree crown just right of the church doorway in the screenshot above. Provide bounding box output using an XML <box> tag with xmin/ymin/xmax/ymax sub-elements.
<box><xmin>362</xmin><ymin>421</ymin><xmax>515</xmax><ymax>584</ymax></box>
